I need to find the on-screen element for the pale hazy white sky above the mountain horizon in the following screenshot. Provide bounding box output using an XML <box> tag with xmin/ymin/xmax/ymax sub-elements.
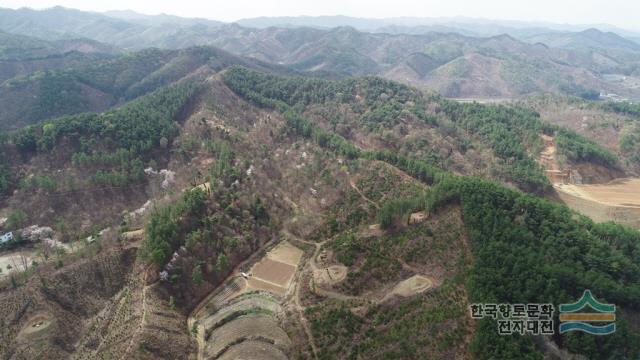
<box><xmin>5</xmin><ymin>0</ymin><xmax>640</xmax><ymax>30</ymax></box>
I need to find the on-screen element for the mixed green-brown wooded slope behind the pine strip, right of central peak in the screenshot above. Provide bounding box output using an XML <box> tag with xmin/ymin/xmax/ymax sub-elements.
<box><xmin>225</xmin><ymin>68</ymin><xmax>617</xmax><ymax>193</ymax></box>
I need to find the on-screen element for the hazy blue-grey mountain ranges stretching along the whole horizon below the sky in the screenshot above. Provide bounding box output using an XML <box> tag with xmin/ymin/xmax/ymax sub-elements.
<box><xmin>0</xmin><ymin>7</ymin><xmax>640</xmax><ymax>99</ymax></box>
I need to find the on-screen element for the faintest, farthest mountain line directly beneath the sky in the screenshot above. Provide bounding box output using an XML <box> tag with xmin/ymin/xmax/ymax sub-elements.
<box><xmin>0</xmin><ymin>6</ymin><xmax>640</xmax><ymax>43</ymax></box>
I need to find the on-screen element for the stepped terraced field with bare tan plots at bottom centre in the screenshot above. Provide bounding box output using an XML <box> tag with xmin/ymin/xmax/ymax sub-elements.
<box><xmin>190</xmin><ymin>241</ymin><xmax>303</xmax><ymax>359</ymax></box>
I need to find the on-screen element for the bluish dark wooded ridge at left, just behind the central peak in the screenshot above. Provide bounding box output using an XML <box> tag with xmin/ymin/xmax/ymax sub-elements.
<box><xmin>0</xmin><ymin>42</ymin><xmax>282</xmax><ymax>130</ymax></box>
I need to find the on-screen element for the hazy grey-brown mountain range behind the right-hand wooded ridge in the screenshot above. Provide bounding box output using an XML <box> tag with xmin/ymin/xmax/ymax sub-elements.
<box><xmin>198</xmin><ymin>25</ymin><xmax>638</xmax><ymax>98</ymax></box>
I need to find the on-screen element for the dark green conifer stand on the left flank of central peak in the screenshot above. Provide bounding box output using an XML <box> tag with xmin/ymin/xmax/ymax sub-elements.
<box><xmin>6</xmin><ymin>82</ymin><xmax>199</xmax><ymax>189</ymax></box>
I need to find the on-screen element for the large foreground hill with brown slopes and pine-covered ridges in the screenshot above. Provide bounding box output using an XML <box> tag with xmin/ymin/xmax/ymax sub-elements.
<box><xmin>0</xmin><ymin>55</ymin><xmax>640</xmax><ymax>359</ymax></box>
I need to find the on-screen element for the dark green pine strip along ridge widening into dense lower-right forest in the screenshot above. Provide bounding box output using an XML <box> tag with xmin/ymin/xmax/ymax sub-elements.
<box><xmin>225</xmin><ymin>69</ymin><xmax>640</xmax><ymax>359</ymax></box>
